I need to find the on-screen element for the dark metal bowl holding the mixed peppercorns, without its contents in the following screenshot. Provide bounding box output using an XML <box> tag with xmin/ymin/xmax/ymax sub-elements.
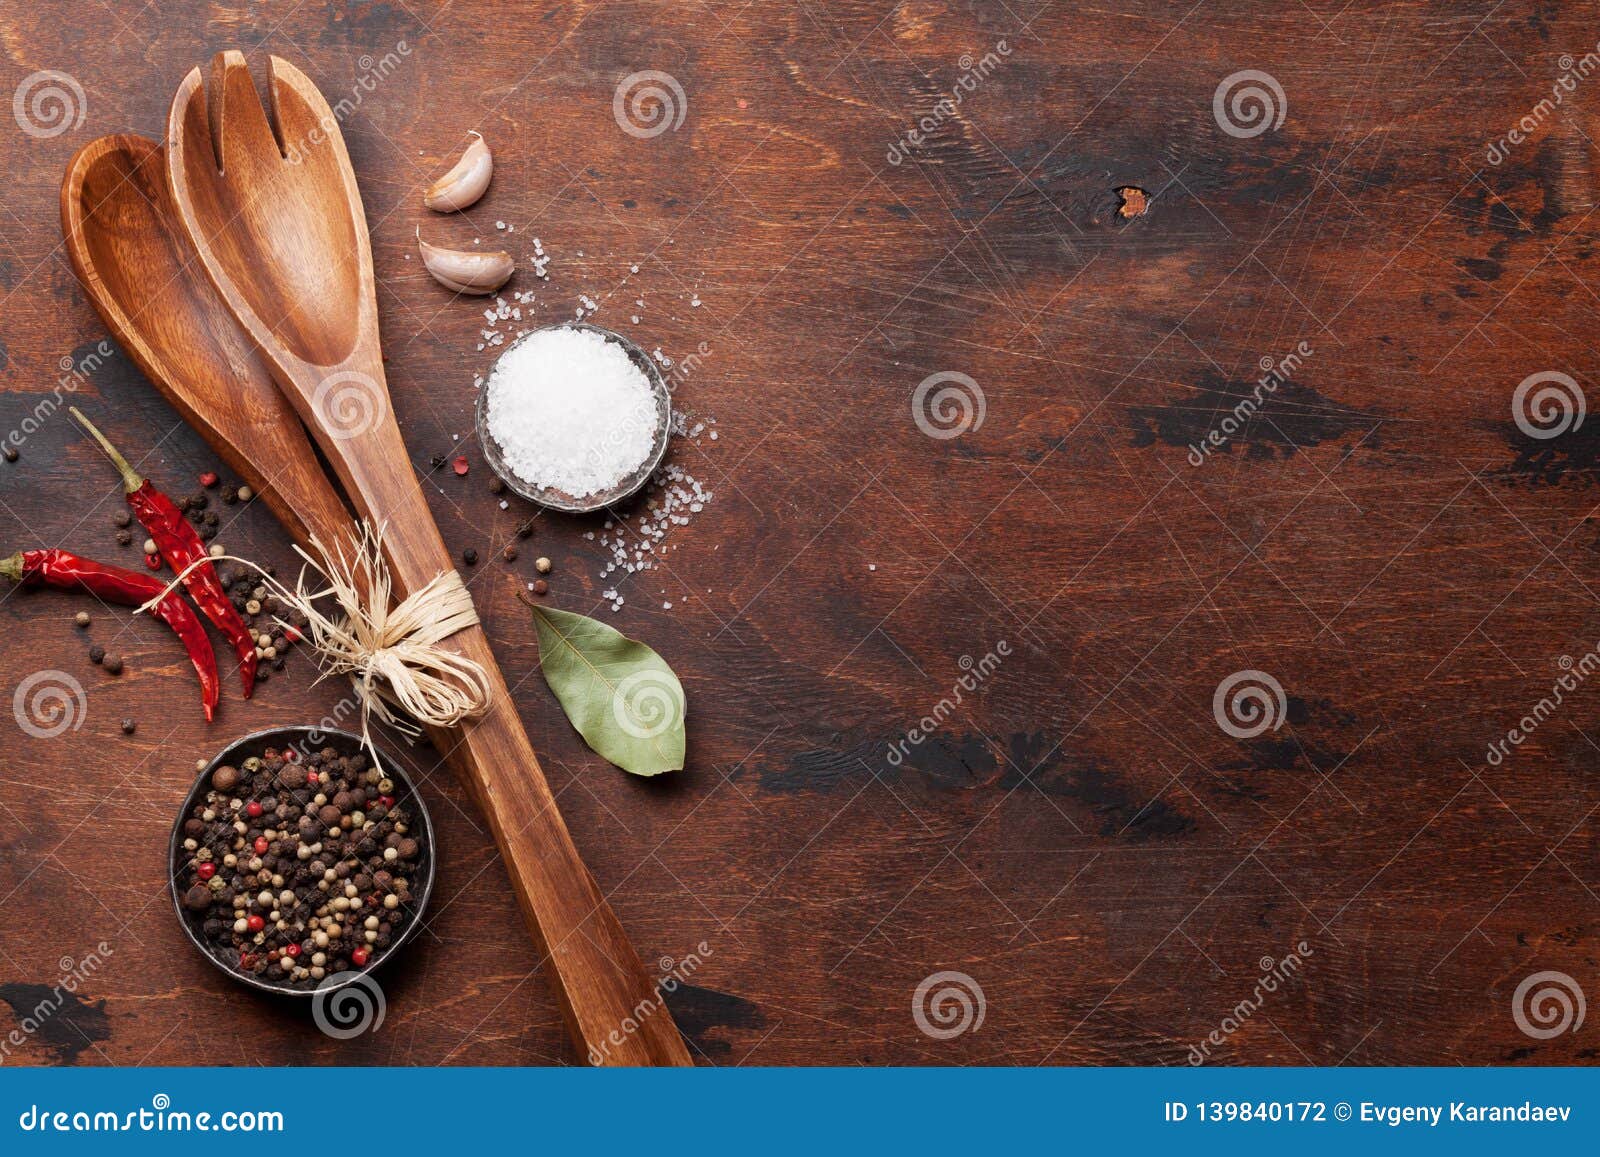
<box><xmin>166</xmin><ymin>727</ymin><xmax>435</xmax><ymax>997</ymax></box>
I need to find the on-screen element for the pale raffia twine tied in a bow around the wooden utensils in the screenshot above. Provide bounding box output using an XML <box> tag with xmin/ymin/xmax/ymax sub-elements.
<box><xmin>149</xmin><ymin>522</ymin><xmax>490</xmax><ymax>760</ymax></box>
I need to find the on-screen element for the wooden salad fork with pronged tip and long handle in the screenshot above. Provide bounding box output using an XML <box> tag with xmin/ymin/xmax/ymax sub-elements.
<box><xmin>166</xmin><ymin>51</ymin><xmax>691</xmax><ymax>1064</ymax></box>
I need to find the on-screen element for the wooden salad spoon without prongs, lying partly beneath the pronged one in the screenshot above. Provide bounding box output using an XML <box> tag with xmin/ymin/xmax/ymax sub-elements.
<box><xmin>61</xmin><ymin>136</ymin><xmax>352</xmax><ymax>544</ymax></box>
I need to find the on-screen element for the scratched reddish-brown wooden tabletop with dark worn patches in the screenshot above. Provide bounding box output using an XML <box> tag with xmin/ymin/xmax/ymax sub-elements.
<box><xmin>0</xmin><ymin>0</ymin><xmax>1600</xmax><ymax>1064</ymax></box>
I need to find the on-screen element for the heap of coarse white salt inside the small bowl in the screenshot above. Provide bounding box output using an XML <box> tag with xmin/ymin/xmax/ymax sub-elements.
<box><xmin>485</xmin><ymin>328</ymin><xmax>659</xmax><ymax>498</ymax></box>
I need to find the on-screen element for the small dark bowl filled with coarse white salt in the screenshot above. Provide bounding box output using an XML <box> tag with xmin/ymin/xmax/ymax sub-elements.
<box><xmin>477</xmin><ymin>322</ymin><xmax>672</xmax><ymax>514</ymax></box>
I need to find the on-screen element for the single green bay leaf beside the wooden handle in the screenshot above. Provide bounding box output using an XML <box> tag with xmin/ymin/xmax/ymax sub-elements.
<box><xmin>533</xmin><ymin>607</ymin><xmax>688</xmax><ymax>776</ymax></box>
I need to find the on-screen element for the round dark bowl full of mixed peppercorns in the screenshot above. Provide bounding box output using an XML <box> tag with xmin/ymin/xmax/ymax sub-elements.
<box><xmin>168</xmin><ymin>727</ymin><xmax>434</xmax><ymax>995</ymax></box>
